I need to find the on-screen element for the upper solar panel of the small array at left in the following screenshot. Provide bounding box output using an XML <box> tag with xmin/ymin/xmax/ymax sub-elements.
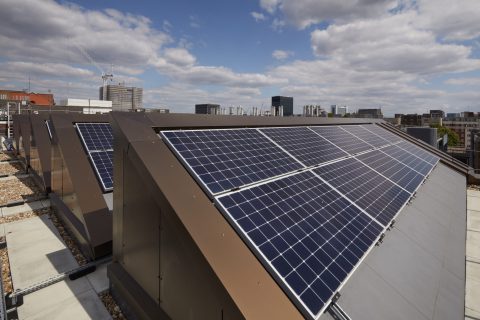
<box><xmin>76</xmin><ymin>123</ymin><xmax>113</xmax><ymax>151</ymax></box>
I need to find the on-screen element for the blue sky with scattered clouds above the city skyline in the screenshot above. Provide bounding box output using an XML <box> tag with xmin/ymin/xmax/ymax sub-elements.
<box><xmin>0</xmin><ymin>0</ymin><xmax>480</xmax><ymax>116</ymax></box>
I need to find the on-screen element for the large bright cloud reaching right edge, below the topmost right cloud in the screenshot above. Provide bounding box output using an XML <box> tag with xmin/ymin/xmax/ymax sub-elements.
<box><xmin>311</xmin><ymin>12</ymin><xmax>480</xmax><ymax>75</ymax></box>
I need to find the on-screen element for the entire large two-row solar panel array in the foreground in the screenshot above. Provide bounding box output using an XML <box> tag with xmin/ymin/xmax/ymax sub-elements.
<box><xmin>161</xmin><ymin>125</ymin><xmax>439</xmax><ymax>319</ymax></box>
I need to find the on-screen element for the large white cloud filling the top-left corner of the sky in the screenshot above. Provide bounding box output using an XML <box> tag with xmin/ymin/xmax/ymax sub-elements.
<box><xmin>0</xmin><ymin>0</ymin><xmax>172</xmax><ymax>67</ymax></box>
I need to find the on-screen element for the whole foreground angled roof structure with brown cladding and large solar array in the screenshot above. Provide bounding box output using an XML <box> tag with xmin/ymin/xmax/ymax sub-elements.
<box><xmin>108</xmin><ymin>112</ymin><xmax>466</xmax><ymax>319</ymax></box>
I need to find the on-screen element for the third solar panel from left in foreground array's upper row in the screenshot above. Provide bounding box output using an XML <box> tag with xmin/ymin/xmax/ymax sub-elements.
<box><xmin>310</xmin><ymin>126</ymin><xmax>372</xmax><ymax>154</ymax></box>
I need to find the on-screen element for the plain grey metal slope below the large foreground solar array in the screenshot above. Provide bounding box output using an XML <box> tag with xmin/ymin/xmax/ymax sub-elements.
<box><xmin>321</xmin><ymin>164</ymin><xmax>466</xmax><ymax>320</ymax></box>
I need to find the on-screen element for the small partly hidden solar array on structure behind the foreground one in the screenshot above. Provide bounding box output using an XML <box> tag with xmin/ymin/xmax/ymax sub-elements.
<box><xmin>76</xmin><ymin>122</ymin><xmax>113</xmax><ymax>191</ymax></box>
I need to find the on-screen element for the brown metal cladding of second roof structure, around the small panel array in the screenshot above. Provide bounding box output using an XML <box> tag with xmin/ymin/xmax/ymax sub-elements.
<box><xmin>51</xmin><ymin>113</ymin><xmax>112</xmax><ymax>259</ymax></box>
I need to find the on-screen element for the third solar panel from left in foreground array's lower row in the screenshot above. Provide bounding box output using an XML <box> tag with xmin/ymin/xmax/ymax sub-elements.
<box><xmin>355</xmin><ymin>151</ymin><xmax>424</xmax><ymax>193</ymax></box>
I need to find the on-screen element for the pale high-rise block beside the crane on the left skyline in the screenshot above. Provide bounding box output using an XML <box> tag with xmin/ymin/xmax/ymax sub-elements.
<box><xmin>99</xmin><ymin>84</ymin><xmax>143</xmax><ymax>111</ymax></box>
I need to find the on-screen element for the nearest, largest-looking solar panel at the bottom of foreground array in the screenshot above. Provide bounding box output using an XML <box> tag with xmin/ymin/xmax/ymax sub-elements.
<box><xmin>216</xmin><ymin>171</ymin><xmax>383</xmax><ymax>319</ymax></box>
